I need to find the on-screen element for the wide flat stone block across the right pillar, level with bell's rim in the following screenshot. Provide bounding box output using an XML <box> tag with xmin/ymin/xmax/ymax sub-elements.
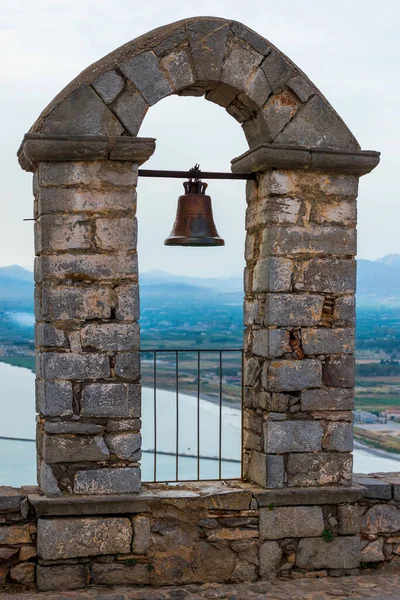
<box><xmin>261</xmin><ymin>225</ymin><xmax>357</xmax><ymax>256</ymax></box>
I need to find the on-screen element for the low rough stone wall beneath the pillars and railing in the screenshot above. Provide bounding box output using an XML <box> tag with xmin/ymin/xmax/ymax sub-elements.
<box><xmin>0</xmin><ymin>473</ymin><xmax>400</xmax><ymax>590</ymax></box>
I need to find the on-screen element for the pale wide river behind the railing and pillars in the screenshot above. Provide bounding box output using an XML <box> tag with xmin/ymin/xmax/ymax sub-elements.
<box><xmin>0</xmin><ymin>362</ymin><xmax>400</xmax><ymax>486</ymax></box>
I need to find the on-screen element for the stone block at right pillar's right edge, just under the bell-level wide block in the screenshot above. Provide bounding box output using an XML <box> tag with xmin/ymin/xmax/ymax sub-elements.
<box><xmin>294</xmin><ymin>258</ymin><xmax>356</xmax><ymax>294</ymax></box>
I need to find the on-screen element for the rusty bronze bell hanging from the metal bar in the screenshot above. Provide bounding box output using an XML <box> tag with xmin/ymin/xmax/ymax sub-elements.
<box><xmin>164</xmin><ymin>165</ymin><xmax>225</xmax><ymax>246</ymax></box>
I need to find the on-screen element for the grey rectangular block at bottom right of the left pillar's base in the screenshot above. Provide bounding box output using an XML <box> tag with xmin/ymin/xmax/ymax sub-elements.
<box><xmin>74</xmin><ymin>467</ymin><xmax>141</xmax><ymax>494</ymax></box>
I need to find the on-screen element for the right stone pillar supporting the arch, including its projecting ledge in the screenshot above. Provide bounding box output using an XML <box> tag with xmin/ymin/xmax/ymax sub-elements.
<box><xmin>233</xmin><ymin>145</ymin><xmax>378</xmax><ymax>488</ymax></box>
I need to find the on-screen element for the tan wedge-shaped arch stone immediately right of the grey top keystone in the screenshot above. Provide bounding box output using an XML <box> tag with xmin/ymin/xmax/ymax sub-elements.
<box><xmin>221</xmin><ymin>40</ymin><xmax>263</xmax><ymax>91</ymax></box>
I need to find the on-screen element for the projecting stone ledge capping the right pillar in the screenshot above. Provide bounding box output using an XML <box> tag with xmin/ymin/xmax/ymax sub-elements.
<box><xmin>231</xmin><ymin>144</ymin><xmax>380</xmax><ymax>175</ymax></box>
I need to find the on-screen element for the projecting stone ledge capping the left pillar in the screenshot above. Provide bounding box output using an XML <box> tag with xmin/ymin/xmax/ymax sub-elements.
<box><xmin>17</xmin><ymin>133</ymin><xmax>156</xmax><ymax>172</ymax></box>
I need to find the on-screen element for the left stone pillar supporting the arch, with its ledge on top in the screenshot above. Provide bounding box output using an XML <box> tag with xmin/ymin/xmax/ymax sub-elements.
<box><xmin>19</xmin><ymin>136</ymin><xmax>154</xmax><ymax>496</ymax></box>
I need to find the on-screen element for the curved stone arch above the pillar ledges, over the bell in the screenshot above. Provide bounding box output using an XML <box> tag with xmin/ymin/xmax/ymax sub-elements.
<box><xmin>21</xmin><ymin>17</ymin><xmax>359</xmax><ymax>157</ymax></box>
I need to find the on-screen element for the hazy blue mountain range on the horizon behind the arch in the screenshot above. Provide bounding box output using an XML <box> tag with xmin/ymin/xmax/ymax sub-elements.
<box><xmin>0</xmin><ymin>254</ymin><xmax>400</xmax><ymax>310</ymax></box>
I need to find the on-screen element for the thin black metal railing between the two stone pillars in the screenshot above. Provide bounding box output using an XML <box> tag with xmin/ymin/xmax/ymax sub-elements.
<box><xmin>141</xmin><ymin>348</ymin><xmax>243</xmax><ymax>482</ymax></box>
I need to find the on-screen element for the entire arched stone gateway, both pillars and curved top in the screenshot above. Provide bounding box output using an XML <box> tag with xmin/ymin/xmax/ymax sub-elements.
<box><xmin>18</xmin><ymin>17</ymin><xmax>379</xmax><ymax>496</ymax></box>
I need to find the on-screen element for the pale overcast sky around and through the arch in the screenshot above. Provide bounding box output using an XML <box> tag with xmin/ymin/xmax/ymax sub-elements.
<box><xmin>0</xmin><ymin>0</ymin><xmax>400</xmax><ymax>276</ymax></box>
